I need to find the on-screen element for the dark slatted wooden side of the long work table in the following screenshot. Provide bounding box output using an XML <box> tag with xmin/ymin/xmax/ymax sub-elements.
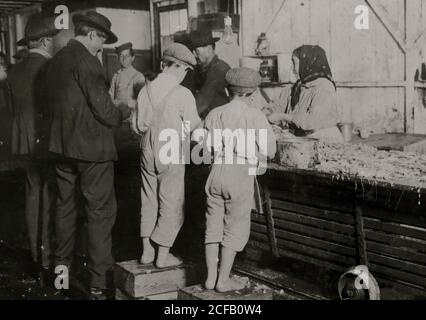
<box><xmin>250</xmin><ymin>164</ymin><xmax>426</xmax><ymax>292</ymax></box>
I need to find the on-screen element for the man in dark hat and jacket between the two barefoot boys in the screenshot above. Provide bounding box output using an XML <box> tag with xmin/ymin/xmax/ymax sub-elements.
<box><xmin>190</xmin><ymin>30</ymin><xmax>231</xmax><ymax>119</ymax></box>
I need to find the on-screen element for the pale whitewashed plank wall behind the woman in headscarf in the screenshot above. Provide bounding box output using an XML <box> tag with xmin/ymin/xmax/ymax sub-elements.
<box><xmin>242</xmin><ymin>0</ymin><xmax>426</xmax><ymax>132</ymax></box>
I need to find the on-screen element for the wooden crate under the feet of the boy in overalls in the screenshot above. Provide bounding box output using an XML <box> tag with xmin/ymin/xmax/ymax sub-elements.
<box><xmin>114</xmin><ymin>260</ymin><xmax>201</xmax><ymax>299</ymax></box>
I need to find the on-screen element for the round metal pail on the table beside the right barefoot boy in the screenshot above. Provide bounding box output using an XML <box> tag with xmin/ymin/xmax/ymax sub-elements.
<box><xmin>277</xmin><ymin>138</ymin><xmax>318</xmax><ymax>169</ymax></box>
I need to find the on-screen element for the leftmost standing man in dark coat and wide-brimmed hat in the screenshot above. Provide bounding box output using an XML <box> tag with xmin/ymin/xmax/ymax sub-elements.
<box><xmin>8</xmin><ymin>15</ymin><xmax>59</xmax><ymax>282</ymax></box>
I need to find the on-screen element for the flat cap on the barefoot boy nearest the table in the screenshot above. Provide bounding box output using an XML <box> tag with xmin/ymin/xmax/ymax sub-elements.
<box><xmin>225</xmin><ymin>67</ymin><xmax>262</xmax><ymax>94</ymax></box>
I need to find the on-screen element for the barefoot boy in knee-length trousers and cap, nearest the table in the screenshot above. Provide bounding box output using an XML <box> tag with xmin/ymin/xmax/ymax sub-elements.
<box><xmin>204</xmin><ymin>68</ymin><xmax>276</xmax><ymax>292</ymax></box>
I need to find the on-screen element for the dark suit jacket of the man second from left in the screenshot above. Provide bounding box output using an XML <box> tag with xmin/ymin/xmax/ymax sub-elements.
<box><xmin>47</xmin><ymin>40</ymin><xmax>122</xmax><ymax>162</ymax></box>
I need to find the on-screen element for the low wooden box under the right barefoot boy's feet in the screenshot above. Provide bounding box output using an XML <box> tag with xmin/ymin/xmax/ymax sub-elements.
<box><xmin>178</xmin><ymin>279</ymin><xmax>274</xmax><ymax>301</ymax></box>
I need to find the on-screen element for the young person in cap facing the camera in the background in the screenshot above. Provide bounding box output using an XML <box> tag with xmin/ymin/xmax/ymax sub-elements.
<box><xmin>109</xmin><ymin>42</ymin><xmax>145</xmax><ymax>108</ymax></box>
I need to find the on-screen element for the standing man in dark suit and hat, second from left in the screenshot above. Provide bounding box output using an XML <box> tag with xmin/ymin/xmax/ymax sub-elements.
<box><xmin>47</xmin><ymin>11</ymin><xmax>130</xmax><ymax>299</ymax></box>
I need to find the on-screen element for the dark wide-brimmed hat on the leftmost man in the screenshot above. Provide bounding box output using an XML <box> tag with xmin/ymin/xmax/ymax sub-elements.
<box><xmin>16</xmin><ymin>14</ymin><xmax>60</xmax><ymax>46</ymax></box>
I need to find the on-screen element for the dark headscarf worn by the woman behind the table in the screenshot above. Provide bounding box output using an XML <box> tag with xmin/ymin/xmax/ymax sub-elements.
<box><xmin>291</xmin><ymin>45</ymin><xmax>336</xmax><ymax>110</ymax></box>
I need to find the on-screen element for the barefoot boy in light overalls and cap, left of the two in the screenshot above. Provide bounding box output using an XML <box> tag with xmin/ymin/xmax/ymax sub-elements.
<box><xmin>132</xmin><ymin>43</ymin><xmax>201</xmax><ymax>268</ymax></box>
